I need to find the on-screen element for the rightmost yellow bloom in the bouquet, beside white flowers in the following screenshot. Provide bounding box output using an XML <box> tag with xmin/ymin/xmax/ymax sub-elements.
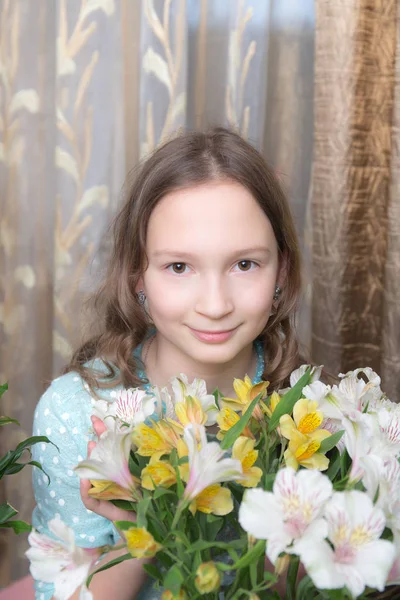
<box><xmin>279</xmin><ymin>398</ymin><xmax>331</xmax><ymax>471</ymax></box>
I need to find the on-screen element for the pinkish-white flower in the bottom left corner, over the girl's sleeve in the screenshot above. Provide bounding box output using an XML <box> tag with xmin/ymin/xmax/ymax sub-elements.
<box><xmin>25</xmin><ymin>517</ymin><xmax>103</xmax><ymax>600</ymax></box>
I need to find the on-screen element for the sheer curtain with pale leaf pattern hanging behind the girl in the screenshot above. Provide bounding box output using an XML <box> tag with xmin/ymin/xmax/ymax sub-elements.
<box><xmin>0</xmin><ymin>0</ymin><xmax>312</xmax><ymax>585</ymax></box>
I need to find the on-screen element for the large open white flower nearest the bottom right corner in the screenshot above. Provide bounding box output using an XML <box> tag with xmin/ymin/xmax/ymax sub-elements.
<box><xmin>297</xmin><ymin>490</ymin><xmax>396</xmax><ymax>597</ymax></box>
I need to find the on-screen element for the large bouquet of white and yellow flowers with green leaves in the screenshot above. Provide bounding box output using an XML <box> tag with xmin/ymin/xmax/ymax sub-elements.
<box><xmin>26</xmin><ymin>365</ymin><xmax>400</xmax><ymax>600</ymax></box>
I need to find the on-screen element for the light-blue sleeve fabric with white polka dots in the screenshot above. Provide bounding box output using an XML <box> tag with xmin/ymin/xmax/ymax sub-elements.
<box><xmin>32</xmin><ymin>361</ymin><xmax>119</xmax><ymax>600</ymax></box>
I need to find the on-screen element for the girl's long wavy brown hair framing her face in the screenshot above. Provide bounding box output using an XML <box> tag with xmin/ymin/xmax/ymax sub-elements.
<box><xmin>66</xmin><ymin>127</ymin><xmax>301</xmax><ymax>389</ymax></box>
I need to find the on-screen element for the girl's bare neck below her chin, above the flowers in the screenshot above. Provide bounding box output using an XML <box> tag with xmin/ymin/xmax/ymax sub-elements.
<box><xmin>144</xmin><ymin>334</ymin><xmax>257</xmax><ymax>397</ymax></box>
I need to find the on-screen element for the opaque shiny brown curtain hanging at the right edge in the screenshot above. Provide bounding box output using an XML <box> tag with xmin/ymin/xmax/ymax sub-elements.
<box><xmin>311</xmin><ymin>0</ymin><xmax>400</xmax><ymax>401</ymax></box>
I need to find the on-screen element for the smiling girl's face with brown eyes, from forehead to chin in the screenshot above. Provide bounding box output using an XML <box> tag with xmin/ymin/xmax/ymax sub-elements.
<box><xmin>138</xmin><ymin>181</ymin><xmax>282</xmax><ymax>364</ymax></box>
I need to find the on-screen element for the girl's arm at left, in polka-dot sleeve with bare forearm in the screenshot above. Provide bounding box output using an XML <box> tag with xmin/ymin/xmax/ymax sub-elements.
<box><xmin>32</xmin><ymin>373</ymin><xmax>150</xmax><ymax>600</ymax></box>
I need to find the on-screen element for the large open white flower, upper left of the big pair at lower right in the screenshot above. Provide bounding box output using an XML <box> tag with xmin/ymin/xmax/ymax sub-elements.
<box><xmin>239</xmin><ymin>467</ymin><xmax>332</xmax><ymax>564</ymax></box>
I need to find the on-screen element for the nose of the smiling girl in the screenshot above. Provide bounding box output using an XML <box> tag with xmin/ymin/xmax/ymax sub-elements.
<box><xmin>195</xmin><ymin>277</ymin><xmax>234</xmax><ymax>320</ymax></box>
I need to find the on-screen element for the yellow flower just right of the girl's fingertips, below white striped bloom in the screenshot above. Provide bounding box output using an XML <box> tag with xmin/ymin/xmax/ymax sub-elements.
<box><xmin>132</xmin><ymin>420</ymin><xmax>183</xmax><ymax>458</ymax></box>
